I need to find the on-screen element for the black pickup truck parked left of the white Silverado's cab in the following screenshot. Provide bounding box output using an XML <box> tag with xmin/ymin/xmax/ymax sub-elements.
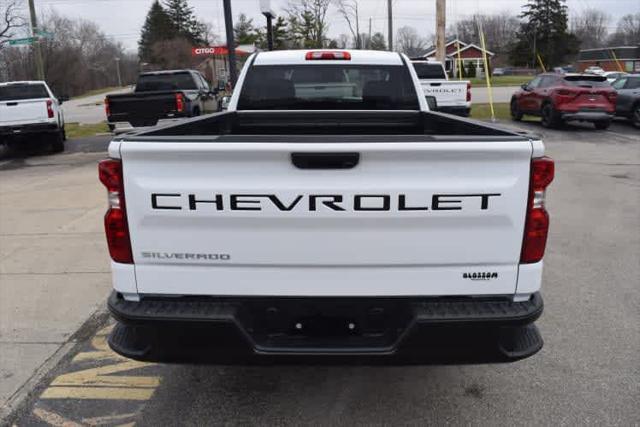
<box><xmin>105</xmin><ymin>70</ymin><xmax>218</xmax><ymax>132</ymax></box>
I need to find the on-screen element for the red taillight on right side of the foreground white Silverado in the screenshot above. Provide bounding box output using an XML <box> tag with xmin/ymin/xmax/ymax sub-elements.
<box><xmin>520</xmin><ymin>157</ymin><xmax>555</xmax><ymax>264</ymax></box>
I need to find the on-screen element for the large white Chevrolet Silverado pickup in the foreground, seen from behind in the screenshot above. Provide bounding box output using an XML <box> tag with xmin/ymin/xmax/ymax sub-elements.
<box><xmin>99</xmin><ymin>50</ymin><xmax>554</xmax><ymax>364</ymax></box>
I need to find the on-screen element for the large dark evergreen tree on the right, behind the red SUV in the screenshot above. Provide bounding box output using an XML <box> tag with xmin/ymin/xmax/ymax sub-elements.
<box><xmin>509</xmin><ymin>0</ymin><xmax>579</xmax><ymax>68</ymax></box>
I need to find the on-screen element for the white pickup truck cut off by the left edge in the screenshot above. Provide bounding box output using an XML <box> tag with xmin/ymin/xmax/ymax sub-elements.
<box><xmin>0</xmin><ymin>81</ymin><xmax>68</xmax><ymax>152</ymax></box>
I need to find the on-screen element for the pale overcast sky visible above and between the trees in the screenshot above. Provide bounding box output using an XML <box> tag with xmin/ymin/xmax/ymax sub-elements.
<box><xmin>24</xmin><ymin>0</ymin><xmax>640</xmax><ymax>49</ymax></box>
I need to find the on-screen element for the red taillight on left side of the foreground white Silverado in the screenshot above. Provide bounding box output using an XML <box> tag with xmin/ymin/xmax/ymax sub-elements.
<box><xmin>98</xmin><ymin>159</ymin><xmax>133</xmax><ymax>264</ymax></box>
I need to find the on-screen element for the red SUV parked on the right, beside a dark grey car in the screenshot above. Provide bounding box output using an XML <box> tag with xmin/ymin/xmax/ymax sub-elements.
<box><xmin>511</xmin><ymin>73</ymin><xmax>617</xmax><ymax>129</ymax></box>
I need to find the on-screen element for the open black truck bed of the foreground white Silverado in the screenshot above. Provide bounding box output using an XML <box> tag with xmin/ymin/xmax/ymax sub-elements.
<box><xmin>123</xmin><ymin>111</ymin><xmax>530</xmax><ymax>142</ymax></box>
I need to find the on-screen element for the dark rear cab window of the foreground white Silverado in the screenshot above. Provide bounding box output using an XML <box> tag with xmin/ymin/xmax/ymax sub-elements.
<box><xmin>238</xmin><ymin>63</ymin><xmax>420</xmax><ymax>110</ymax></box>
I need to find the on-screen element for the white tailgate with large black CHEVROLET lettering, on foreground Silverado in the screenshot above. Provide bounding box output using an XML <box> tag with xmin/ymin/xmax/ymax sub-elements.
<box><xmin>119</xmin><ymin>137</ymin><xmax>532</xmax><ymax>296</ymax></box>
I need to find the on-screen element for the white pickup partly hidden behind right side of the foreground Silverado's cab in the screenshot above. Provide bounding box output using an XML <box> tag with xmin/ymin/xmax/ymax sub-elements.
<box><xmin>411</xmin><ymin>60</ymin><xmax>471</xmax><ymax>117</ymax></box>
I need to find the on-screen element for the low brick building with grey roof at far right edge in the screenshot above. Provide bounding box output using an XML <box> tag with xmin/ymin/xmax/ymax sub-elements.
<box><xmin>577</xmin><ymin>46</ymin><xmax>640</xmax><ymax>73</ymax></box>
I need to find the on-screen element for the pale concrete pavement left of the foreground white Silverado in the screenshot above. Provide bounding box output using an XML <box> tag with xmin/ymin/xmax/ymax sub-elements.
<box><xmin>0</xmin><ymin>153</ymin><xmax>111</xmax><ymax>416</ymax></box>
